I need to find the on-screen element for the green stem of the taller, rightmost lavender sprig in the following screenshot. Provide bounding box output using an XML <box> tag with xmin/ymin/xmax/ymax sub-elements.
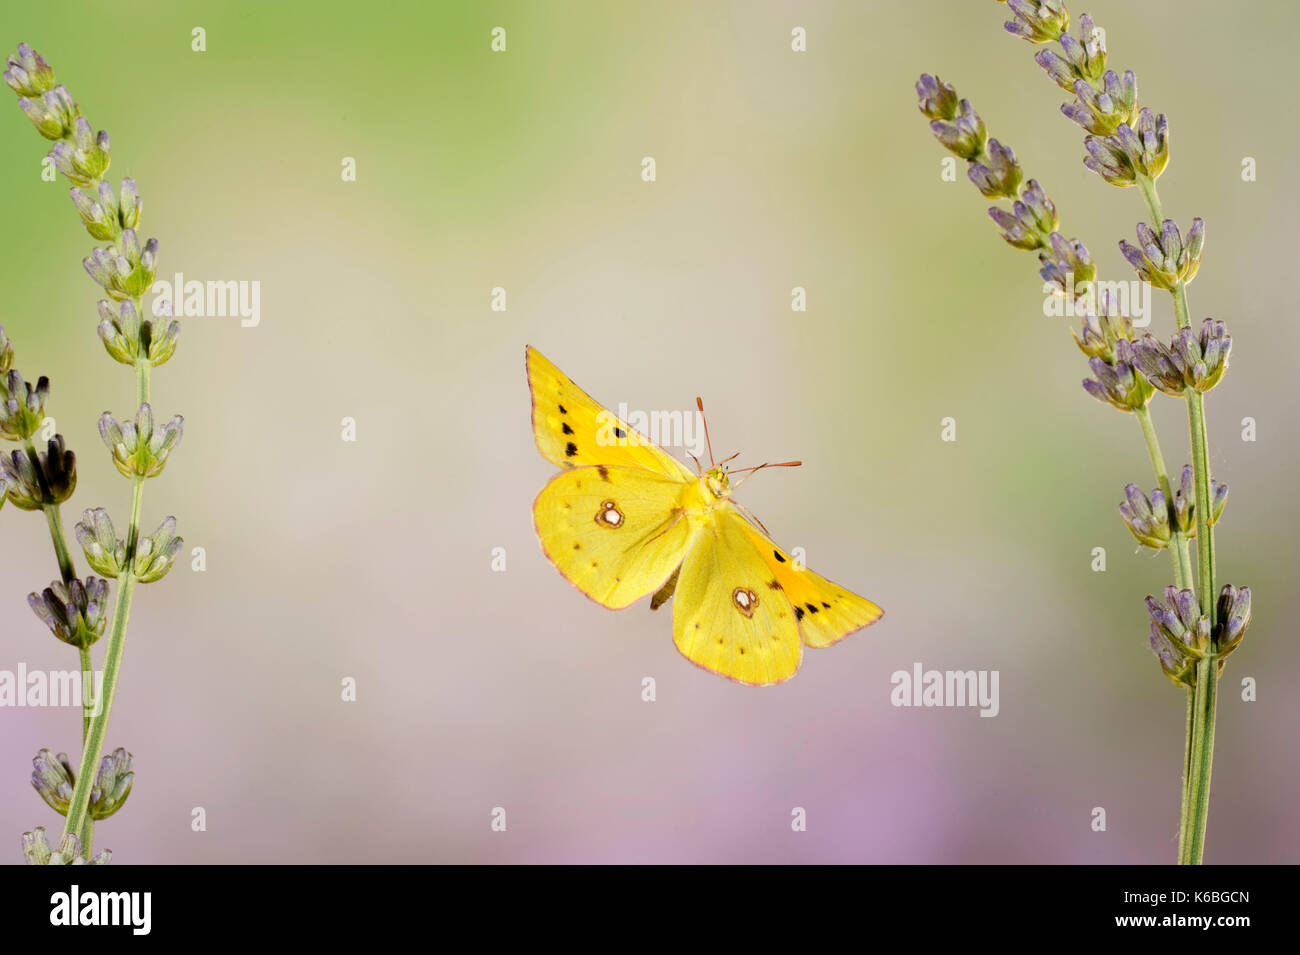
<box><xmin>1138</xmin><ymin>175</ymin><xmax>1218</xmax><ymax>865</ymax></box>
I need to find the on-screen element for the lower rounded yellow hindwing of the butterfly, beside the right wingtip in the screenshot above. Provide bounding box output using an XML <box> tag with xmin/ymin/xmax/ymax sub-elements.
<box><xmin>672</xmin><ymin>504</ymin><xmax>803</xmax><ymax>686</ymax></box>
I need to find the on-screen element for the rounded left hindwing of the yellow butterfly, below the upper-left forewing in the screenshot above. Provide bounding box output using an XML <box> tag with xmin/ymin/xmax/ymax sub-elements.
<box><xmin>533</xmin><ymin>464</ymin><xmax>692</xmax><ymax>609</ymax></box>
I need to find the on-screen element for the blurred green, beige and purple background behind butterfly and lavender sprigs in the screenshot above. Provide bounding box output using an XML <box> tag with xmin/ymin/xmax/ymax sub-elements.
<box><xmin>0</xmin><ymin>0</ymin><xmax>1300</xmax><ymax>863</ymax></box>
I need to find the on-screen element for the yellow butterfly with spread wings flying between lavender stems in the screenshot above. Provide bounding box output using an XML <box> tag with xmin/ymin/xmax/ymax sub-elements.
<box><xmin>527</xmin><ymin>347</ymin><xmax>883</xmax><ymax>686</ymax></box>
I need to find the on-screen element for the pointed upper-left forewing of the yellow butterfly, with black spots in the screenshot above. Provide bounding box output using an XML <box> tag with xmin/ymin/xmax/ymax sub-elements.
<box><xmin>527</xmin><ymin>347</ymin><xmax>696</xmax><ymax>481</ymax></box>
